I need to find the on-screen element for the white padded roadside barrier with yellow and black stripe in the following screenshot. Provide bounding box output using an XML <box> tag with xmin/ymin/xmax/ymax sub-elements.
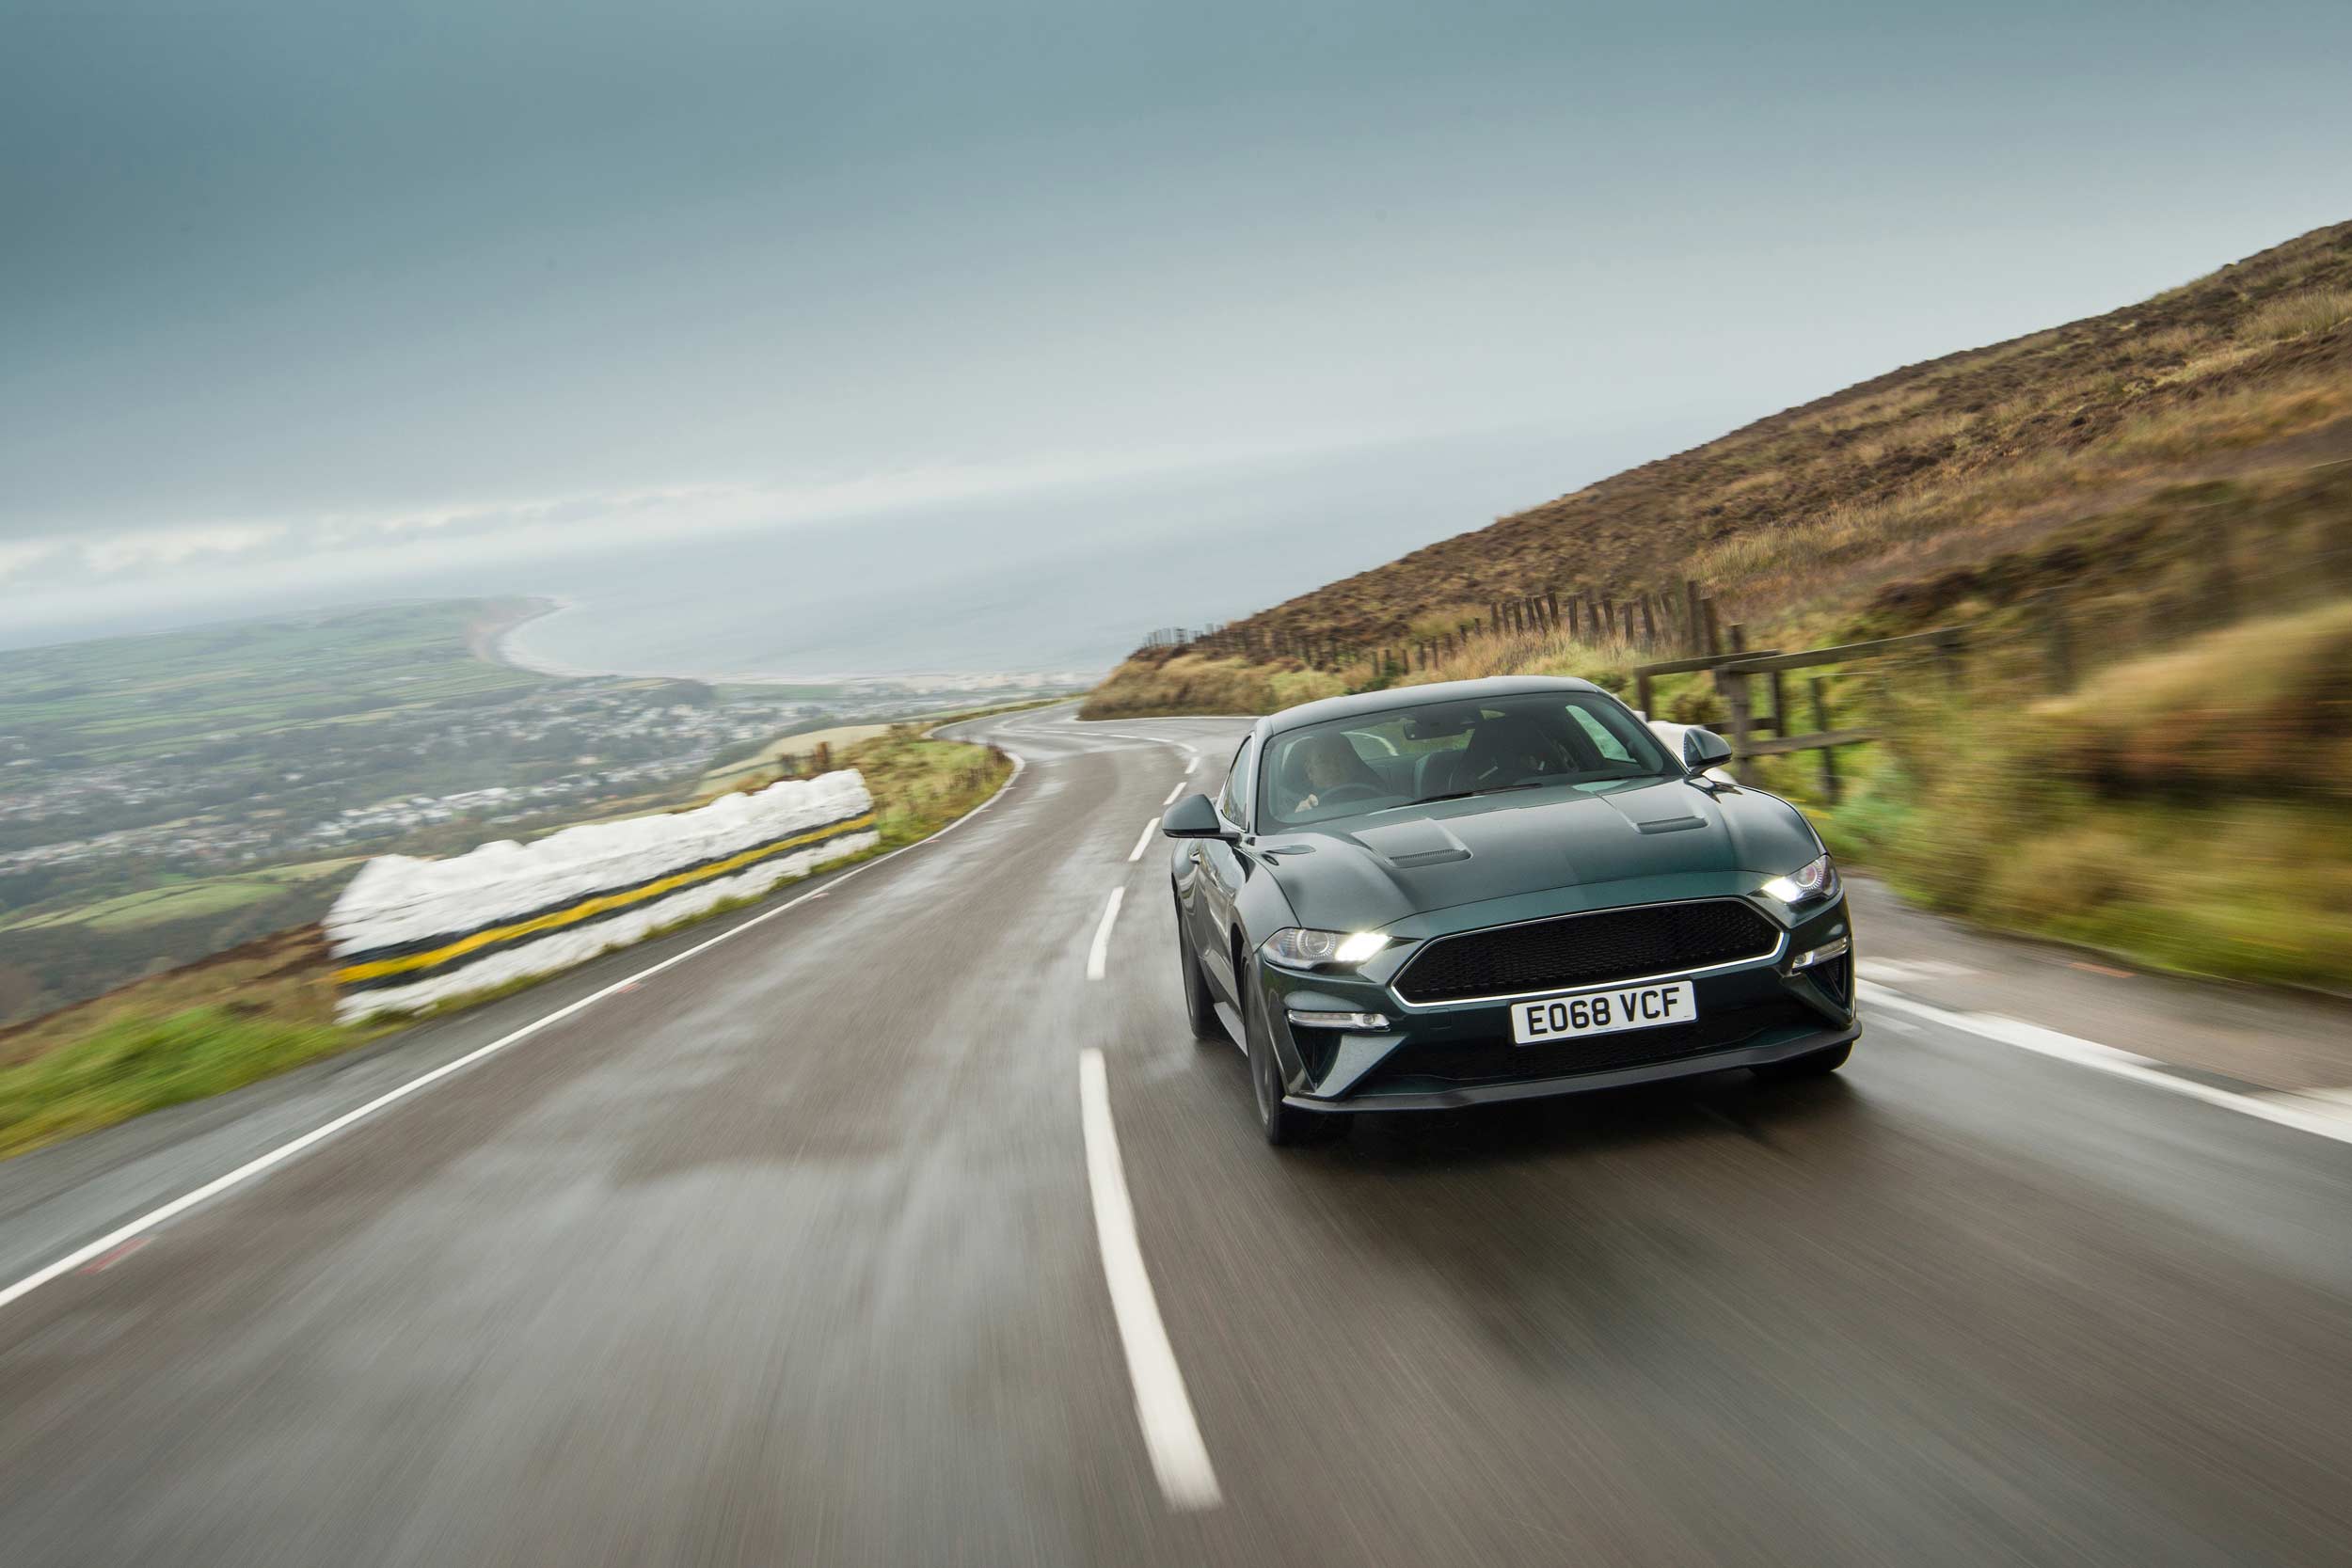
<box><xmin>325</xmin><ymin>768</ymin><xmax>878</xmax><ymax>1022</ymax></box>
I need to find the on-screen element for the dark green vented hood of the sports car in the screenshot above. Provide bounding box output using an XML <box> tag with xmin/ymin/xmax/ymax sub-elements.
<box><xmin>1259</xmin><ymin>781</ymin><xmax>1820</xmax><ymax>931</ymax></box>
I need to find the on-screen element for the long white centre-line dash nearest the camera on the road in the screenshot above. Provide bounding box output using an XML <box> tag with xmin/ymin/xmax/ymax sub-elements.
<box><xmin>1077</xmin><ymin>1049</ymin><xmax>1223</xmax><ymax>1510</ymax></box>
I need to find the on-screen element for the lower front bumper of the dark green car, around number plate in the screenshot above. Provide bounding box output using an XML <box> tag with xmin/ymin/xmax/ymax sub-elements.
<box><xmin>1259</xmin><ymin>895</ymin><xmax>1861</xmax><ymax>1112</ymax></box>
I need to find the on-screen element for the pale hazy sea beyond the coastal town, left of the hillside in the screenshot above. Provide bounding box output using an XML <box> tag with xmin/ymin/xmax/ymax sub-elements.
<box><xmin>508</xmin><ymin>419</ymin><xmax>1720</xmax><ymax>679</ymax></box>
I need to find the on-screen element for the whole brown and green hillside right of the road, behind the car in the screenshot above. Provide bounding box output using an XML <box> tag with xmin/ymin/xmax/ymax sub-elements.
<box><xmin>1087</xmin><ymin>223</ymin><xmax>2352</xmax><ymax>985</ymax></box>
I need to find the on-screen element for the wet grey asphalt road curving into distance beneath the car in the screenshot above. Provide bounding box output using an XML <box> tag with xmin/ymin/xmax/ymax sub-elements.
<box><xmin>0</xmin><ymin>712</ymin><xmax>2352</xmax><ymax>1568</ymax></box>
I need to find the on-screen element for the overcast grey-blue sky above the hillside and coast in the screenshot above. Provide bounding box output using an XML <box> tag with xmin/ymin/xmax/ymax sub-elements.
<box><xmin>0</xmin><ymin>0</ymin><xmax>2352</xmax><ymax>663</ymax></box>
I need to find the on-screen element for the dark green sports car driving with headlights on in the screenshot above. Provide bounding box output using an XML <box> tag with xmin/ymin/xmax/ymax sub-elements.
<box><xmin>1162</xmin><ymin>679</ymin><xmax>1861</xmax><ymax>1143</ymax></box>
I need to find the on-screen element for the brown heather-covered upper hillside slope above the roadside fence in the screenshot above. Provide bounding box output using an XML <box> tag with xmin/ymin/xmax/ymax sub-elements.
<box><xmin>1110</xmin><ymin>223</ymin><xmax>2352</xmax><ymax>658</ymax></box>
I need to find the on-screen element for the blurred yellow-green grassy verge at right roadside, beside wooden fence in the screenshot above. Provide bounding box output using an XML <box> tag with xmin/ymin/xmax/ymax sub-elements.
<box><xmin>1778</xmin><ymin>604</ymin><xmax>2352</xmax><ymax>990</ymax></box>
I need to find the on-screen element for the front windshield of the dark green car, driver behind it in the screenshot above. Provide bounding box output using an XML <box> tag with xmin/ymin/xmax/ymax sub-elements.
<box><xmin>1259</xmin><ymin>691</ymin><xmax>1682</xmax><ymax>828</ymax></box>
